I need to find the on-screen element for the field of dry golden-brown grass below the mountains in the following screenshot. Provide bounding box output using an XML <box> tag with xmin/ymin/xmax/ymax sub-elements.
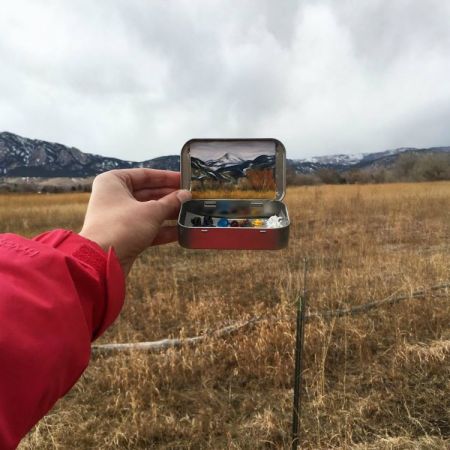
<box><xmin>0</xmin><ymin>182</ymin><xmax>450</xmax><ymax>450</ymax></box>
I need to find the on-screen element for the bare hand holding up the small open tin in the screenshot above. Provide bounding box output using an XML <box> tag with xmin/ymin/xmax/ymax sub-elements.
<box><xmin>79</xmin><ymin>169</ymin><xmax>191</xmax><ymax>276</ymax></box>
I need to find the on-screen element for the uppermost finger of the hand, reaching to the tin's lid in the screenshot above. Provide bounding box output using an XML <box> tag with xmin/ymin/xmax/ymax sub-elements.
<box><xmin>114</xmin><ymin>168</ymin><xmax>180</xmax><ymax>191</ymax></box>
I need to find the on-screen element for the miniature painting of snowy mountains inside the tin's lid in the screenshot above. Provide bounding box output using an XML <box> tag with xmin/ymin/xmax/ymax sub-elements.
<box><xmin>190</xmin><ymin>140</ymin><xmax>276</xmax><ymax>199</ymax></box>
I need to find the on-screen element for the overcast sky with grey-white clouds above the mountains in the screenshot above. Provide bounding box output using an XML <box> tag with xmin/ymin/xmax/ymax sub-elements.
<box><xmin>0</xmin><ymin>0</ymin><xmax>450</xmax><ymax>160</ymax></box>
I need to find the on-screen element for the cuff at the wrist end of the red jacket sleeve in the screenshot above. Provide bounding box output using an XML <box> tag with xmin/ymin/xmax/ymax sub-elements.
<box><xmin>33</xmin><ymin>229</ymin><xmax>125</xmax><ymax>340</ymax></box>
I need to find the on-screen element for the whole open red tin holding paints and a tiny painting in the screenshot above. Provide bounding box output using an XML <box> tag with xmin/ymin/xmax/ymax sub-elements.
<box><xmin>178</xmin><ymin>139</ymin><xmax>290</xmax><ymax>250</ymax></box>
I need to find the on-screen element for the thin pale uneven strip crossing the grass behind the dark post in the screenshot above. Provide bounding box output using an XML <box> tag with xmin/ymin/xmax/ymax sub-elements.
<box><xmin>92</xmin><ymin>281</ymin><xmax>450</xmax><ymax>354</ymax></box>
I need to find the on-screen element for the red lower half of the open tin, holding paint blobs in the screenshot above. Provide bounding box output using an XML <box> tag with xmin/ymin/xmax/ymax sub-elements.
<box><xmin>178</xmin><ymin>199</ymin><xmax>290</xmax><ymax>250</ymax></box>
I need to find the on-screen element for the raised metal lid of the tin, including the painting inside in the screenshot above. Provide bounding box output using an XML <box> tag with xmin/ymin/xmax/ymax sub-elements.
<box><xmin>180</xmin><ymin>139</ymin><xmax>286</xmax><ymax>200</ymax></box>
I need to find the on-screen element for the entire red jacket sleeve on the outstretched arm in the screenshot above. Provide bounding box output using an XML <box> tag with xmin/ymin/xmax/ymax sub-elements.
<box><xmin>0</xmin><ymin>230</ymin><xmax>125</xmax><ymax>450</ymax></box>
